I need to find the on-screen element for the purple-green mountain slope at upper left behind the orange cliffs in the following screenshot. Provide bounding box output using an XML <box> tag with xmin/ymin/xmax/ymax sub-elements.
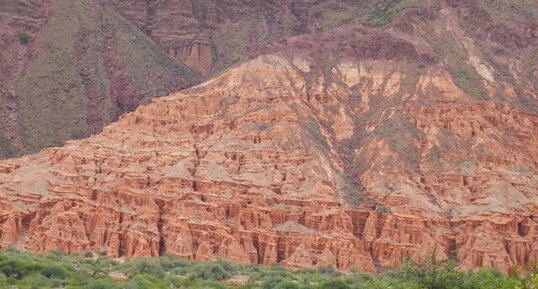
<box><xmin>0</xmin><ymin>0</ymin><xmax>195</xmax><ymax>157</ymax></box>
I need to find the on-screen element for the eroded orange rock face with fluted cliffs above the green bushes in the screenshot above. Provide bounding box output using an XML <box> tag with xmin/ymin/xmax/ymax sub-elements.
<box><xmin>0</xmin><ymin>54</ymin><xmax>538</xmax><ymax>272</ymax></box>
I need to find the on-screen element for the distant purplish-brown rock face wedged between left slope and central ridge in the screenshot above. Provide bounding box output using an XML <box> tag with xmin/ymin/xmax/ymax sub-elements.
<box><xmin>106</xmin><ymin>0</ymin><xmax>374</xmax><ymax>76</ymax></box>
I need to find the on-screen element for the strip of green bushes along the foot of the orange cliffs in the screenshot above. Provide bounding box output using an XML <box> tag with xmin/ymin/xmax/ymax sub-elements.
<box><xmin>0</xmin><ymin>250</ymin><xmax>538</xmax><ymax>289</ymax></box>
